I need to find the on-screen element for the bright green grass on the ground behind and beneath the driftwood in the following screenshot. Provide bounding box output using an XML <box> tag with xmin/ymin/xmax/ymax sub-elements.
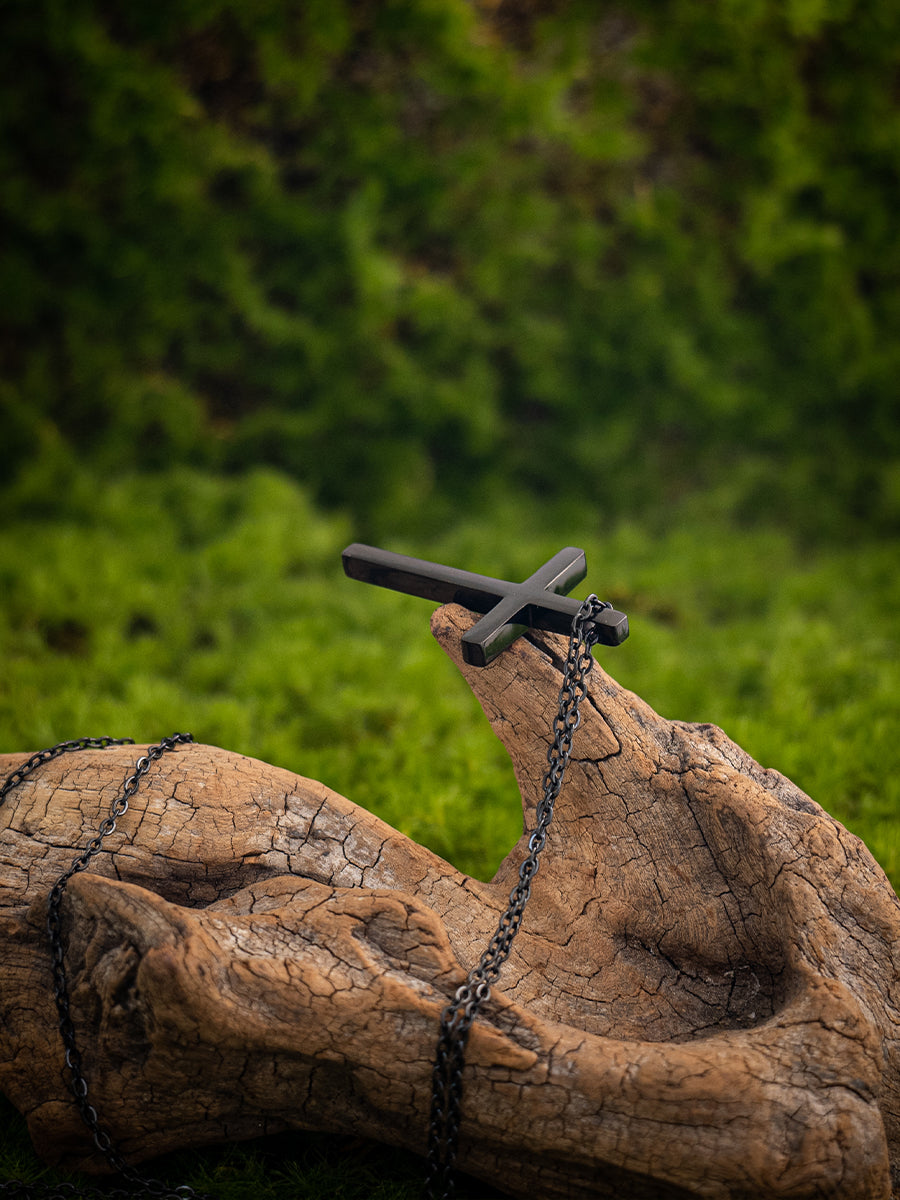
<box><xmin>0</xmin><ymin>470</ymin><xmax>900</xmax><ymax>1200</ymax></box>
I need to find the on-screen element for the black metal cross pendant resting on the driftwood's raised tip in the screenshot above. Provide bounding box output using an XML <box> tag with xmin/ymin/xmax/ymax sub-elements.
<box><xmin>341</xmin><ymin>542</ymin><xmax>628</xmax><ymax>667</ymax></box>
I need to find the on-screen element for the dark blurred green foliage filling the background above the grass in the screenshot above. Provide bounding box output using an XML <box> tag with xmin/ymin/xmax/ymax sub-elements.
<box><xmin>0</xmin><ymin>0</ymin><xmax>900</xmax><ymax>536</ymax></box>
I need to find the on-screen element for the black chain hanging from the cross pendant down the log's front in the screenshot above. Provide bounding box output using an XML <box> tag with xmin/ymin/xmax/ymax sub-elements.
<box><xmin>425</xmin><ymin>595</ymin><xmax>612</xmax><ymax>1200</ymax></box>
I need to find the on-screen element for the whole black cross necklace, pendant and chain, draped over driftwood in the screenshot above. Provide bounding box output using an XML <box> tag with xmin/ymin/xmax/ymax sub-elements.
<box><xmin>0</xmin><ymin>542</ymin><xmax>629</xmax><ymax>1200</ymax></box>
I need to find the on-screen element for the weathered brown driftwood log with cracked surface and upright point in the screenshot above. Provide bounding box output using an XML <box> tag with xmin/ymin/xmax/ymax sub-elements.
<box><xmin>0</xmin><ymin>606</ymin><xmax>900</xmax><ymax>1200</ymax></box>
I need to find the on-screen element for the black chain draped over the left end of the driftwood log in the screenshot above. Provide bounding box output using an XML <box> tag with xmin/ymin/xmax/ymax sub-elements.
<box><xmin>0</xmin><ymin>733</ymin><xmax>214</xmax><ymax>1200</ymax></box>
